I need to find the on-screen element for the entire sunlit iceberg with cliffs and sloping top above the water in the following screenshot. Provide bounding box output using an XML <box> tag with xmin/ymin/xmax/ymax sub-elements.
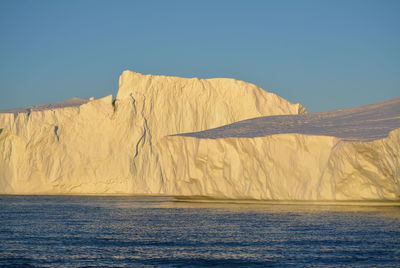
<box><xmin>0</xmin><ymin>71</ymin><xmax>400</xmax><ymax>200</ymax></box>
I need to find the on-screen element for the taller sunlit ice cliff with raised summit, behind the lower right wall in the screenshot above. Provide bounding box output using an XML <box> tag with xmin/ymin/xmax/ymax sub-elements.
<box><xmin>0</xmin><ymin>71</ymin><xmax>305</xmax><ymax>194</ymax></box>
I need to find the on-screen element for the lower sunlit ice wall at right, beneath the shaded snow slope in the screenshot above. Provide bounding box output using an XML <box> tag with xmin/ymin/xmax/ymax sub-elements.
<box><xmin>159</xmin><ymin>129</ymin><xmax>400</xmax><ymax>200</ymax></box>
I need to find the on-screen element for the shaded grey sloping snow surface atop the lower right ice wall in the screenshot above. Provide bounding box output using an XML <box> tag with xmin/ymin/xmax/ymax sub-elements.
<box><xmin>177</xmin><ymin>97</ymin><xmax>400</xmax><ymax>141</ymax></box>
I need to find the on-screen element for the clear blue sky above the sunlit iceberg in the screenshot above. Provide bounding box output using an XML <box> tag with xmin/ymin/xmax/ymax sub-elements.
<box><xmin>0</xmin><ymin>0</ymin><xmax>400</xmax><ymax>112</ymax></box>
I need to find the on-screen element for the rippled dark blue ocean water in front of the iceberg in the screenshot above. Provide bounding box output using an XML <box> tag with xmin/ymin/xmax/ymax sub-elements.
<box><xmin>0</xmin><ymin>196</ymin><xmax>400</xmax><ymax>267</ymax></box>
